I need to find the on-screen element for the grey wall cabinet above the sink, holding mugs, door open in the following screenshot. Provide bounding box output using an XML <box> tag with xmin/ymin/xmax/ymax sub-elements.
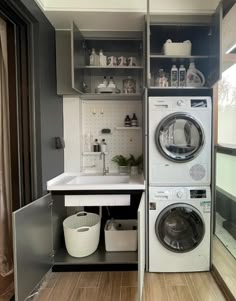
<box><xmin>56</xmin><ymin>23</ymin><xmax>144</xmax><ymax>99</ymax></box>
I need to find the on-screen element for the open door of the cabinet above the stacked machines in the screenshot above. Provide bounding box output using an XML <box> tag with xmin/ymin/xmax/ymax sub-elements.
<box><xmin>208</xmin><ymin>2</ymin><xmax>223</xmax><ymax>87</ymax></box>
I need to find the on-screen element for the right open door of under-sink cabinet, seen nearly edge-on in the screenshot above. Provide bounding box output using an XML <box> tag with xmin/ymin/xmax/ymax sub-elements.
<box><xmin>138</xmin><ymin>192</ymin><xmax>146</xmax><ymax>301</ymax></box>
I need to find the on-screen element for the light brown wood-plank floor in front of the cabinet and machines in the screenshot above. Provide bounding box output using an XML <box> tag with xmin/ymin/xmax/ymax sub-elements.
<box><xmin>34</xmin><ymin>272</ymin><xmax>225</xmax><ymax>301</ymax></box>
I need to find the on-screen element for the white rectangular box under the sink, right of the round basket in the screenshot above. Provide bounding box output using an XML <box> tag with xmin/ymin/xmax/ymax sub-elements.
<box><xmin>104</xmin><ymin>219</ymin><xmax>138</xmax><ymax>252</ymax></box>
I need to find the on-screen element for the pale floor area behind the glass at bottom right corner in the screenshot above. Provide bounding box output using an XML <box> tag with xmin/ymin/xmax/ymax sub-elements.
<box><xmin>213</xmin><ymin>237</ymin><xmax>236</xmax><ymax>299</ymax></box>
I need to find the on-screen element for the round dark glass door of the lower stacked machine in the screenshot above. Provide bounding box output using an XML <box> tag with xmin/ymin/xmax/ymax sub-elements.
<box><xmin>155</xmin><ymin>204</ymin><xmax>205</xmax><ymax>253</ymax></box>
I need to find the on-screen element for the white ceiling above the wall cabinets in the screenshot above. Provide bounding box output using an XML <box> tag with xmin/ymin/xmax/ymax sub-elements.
<box><xmin>35</xmin><ymin>0</ymin><xmax>221</xmax><ymax>31</ymax></box>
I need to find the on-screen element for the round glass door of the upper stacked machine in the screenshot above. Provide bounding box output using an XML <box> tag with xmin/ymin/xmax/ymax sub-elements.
<box><xmin>155</xmin><ymin>113</ymin><xmax>204</xmax><ymax>163</ymax></box>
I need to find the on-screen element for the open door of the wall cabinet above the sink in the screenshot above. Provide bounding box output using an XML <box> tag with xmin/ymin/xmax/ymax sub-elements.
<box><xmin>71</xmin><ymin>22</ymin><xmax>85</xmax><ymax>93</ymax></box>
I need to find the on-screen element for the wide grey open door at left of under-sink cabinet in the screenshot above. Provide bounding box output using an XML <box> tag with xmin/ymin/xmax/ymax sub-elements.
<box><xmin>13</xmin><ymin>194</ymin><xmax>52</xmax><ymax>301</ymax></box>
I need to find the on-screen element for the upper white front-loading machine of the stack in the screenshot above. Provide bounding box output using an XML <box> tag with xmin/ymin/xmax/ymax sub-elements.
<box><xmin>148</xmin><ymin>96</ymin><xmax>212</xmax><ymax>186</ymax></box>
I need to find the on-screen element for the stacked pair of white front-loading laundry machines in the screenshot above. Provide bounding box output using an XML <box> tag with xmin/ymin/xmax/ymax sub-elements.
<box><xmin>148</xmin><ymin>96</ymin><xmax>212</xmax><ymax>272</ymax></box>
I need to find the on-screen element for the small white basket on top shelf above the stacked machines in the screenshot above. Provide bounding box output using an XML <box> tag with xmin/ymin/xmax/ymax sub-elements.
<box><xmin>163</xmin><ymin>40</ymin><xmax>192</xmax><ymax>56</ymax></box>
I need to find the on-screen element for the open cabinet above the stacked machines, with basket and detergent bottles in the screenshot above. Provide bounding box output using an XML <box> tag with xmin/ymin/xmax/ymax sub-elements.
<box><xmin>147</xmin><ymin>5</ymin><xmax>222</xmax><ymax>89</ymax></box>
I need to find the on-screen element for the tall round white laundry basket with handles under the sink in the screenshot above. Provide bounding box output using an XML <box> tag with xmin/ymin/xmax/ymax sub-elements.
<box><xmin>63</xmin><ymin>211</ymin><xmax>101</xmax><ymax>257</ymax></box>
